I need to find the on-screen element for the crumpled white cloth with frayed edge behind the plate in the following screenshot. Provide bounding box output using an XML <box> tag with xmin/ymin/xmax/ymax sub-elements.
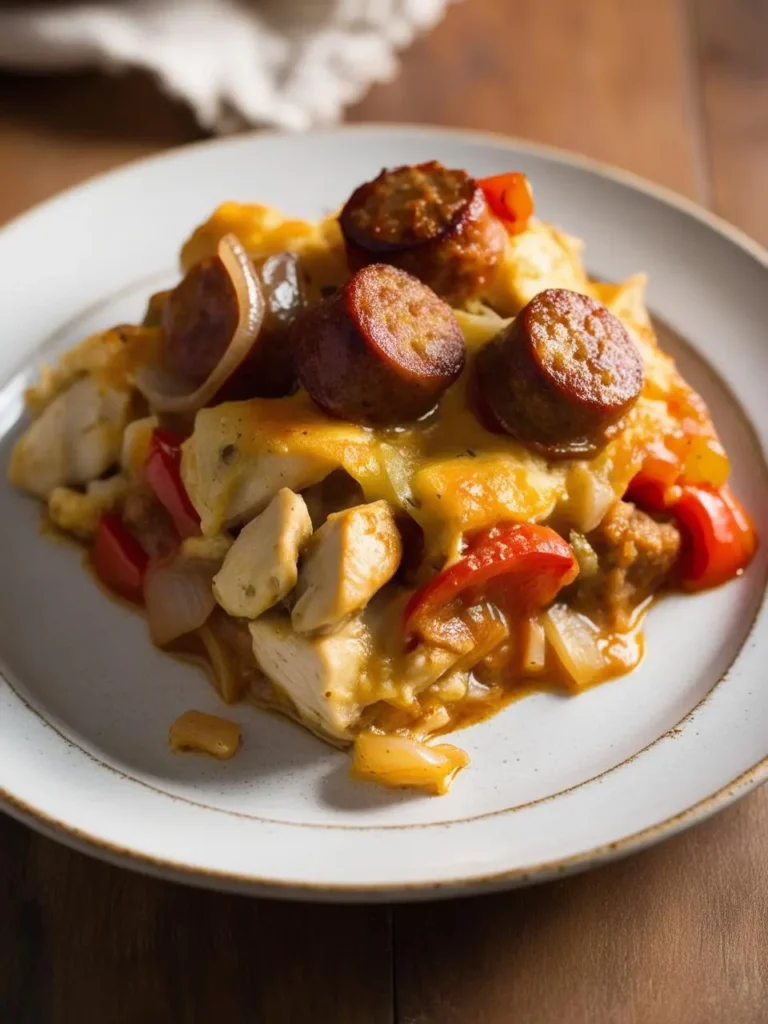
<box><xmin>0</xmin><ymin>0</ymin><xmax>452</xmax><ymax>131</ymax></box>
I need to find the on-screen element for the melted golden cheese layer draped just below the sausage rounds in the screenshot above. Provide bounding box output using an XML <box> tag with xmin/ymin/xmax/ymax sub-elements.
<box><xmin>182</xmin><ymin>339</ymin><xmax>673</xmax><ymax>556</ymax></box>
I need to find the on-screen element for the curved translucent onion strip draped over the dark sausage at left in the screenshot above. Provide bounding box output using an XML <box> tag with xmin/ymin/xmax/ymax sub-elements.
<box><xmin>134</xmin><ymin>234</ymin><xmax>266</xmax><ymax>413</ymax></box>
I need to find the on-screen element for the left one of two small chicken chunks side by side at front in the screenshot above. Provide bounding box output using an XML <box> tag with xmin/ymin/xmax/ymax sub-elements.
<box><xmin>213</xmin><ymin>487</ymin><xmax>312</xmax><ymax>618</ymax></box>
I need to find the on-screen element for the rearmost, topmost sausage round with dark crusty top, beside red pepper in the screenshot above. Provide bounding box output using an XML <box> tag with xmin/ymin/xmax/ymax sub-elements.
<box><xmin>339</xmin><ymin>160</ymin><xmax>507</xmax><ymax>303</ymax></box>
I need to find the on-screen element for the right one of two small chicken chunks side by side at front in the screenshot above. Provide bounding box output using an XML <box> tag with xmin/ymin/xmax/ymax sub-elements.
<box><xmin>291</xmin><ymin>502</ymin><xmax>402</xmax><ymax>633</ymax></box>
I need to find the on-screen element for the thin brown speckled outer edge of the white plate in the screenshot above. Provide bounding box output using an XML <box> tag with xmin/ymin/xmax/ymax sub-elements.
<box><xmin>0</xmin><ymin>124</ymin><xmax>768</xmax><ymax>900</ymax></box>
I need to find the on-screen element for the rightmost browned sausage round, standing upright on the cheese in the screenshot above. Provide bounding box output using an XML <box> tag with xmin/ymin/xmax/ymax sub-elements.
<box><xmin>476</xmin><ymin>288</ymin><xmax>643</xmax><ymax>457</ymax></box>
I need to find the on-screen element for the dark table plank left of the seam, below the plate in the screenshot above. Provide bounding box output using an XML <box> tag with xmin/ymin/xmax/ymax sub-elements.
<box><xmin>0</xmin><ymin>817</ymin><xmax>392</xmax><ymax>1024</ymax></box>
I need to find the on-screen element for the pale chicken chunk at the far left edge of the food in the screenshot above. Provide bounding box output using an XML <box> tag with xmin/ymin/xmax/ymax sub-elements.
<box><xmin>10</xmin><ymin>377</ymin><xmax>130</xmax><ymax>498</ymax></box>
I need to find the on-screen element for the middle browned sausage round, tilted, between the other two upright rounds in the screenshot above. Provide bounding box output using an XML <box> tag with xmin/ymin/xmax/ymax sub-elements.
<box><xmin>294</xmin><ymin>264</ymin><xmax>465</xmax><ymax>424</ymax></box>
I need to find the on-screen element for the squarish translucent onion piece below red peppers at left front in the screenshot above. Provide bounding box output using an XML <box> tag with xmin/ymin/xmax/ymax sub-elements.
<box><xmin>144</xmin><ymin>557</ymin><xmax>216</xmax><ymax>647</ymax></box>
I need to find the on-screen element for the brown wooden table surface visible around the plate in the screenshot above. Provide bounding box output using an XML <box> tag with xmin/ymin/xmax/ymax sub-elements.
<box><xmin>0</xmin><ymin>0</ymin><xmax>768</xmax><ymax>1024</ymax></box>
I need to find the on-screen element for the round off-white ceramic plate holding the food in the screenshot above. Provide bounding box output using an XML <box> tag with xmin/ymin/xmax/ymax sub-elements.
<box><xmin>0</xmin><ymin>126</ymin><xmax>768</xmax><ymax>899</ymax></box>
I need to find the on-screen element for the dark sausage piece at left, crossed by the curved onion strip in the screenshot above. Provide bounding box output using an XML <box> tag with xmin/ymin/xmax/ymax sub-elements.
<box><xmin>162</xmin><ymin>253</ymin><xmax>304</xmax><ymax>400</ymax></box>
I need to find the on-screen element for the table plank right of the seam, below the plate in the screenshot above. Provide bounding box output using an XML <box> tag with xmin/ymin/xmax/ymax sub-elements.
<box><xmin>394</xmin><ymin>792</ymin><xmax>768</xmax><ymax>1024</ymax></box>
